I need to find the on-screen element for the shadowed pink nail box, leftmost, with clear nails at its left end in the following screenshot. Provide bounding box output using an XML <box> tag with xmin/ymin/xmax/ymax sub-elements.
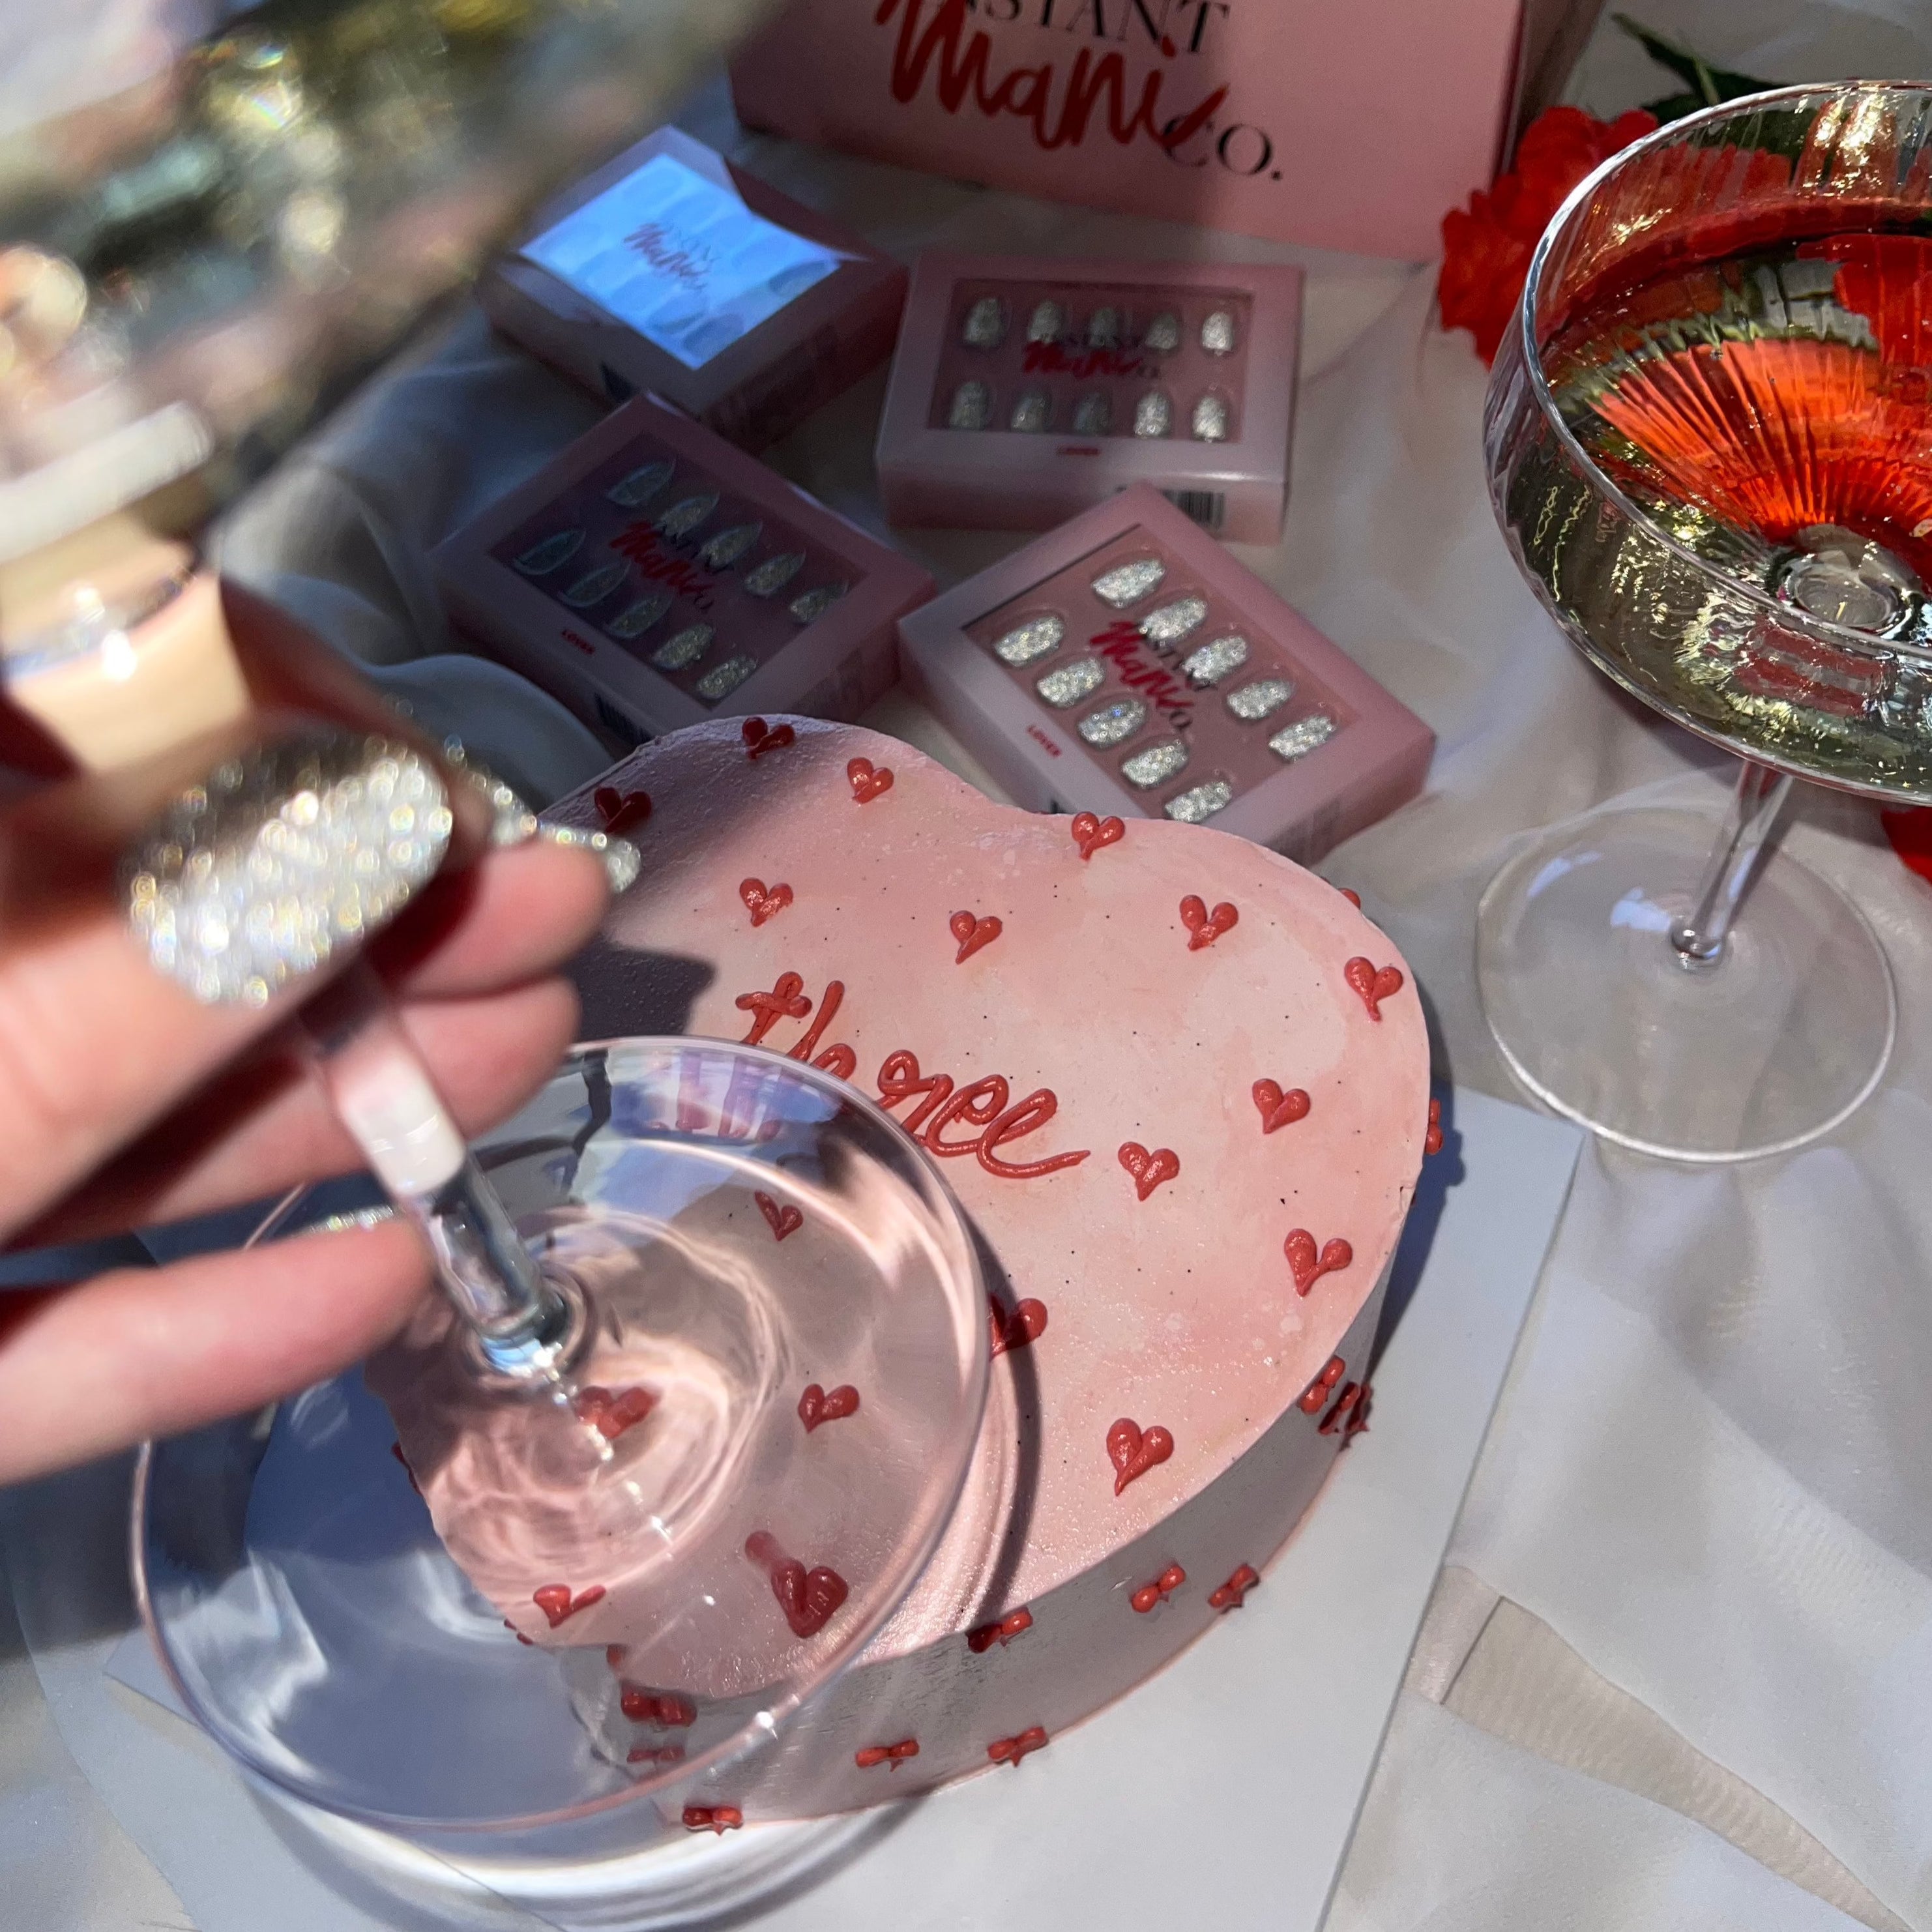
<box><xmin>437</xmin><ymin>398</ymin><xmax>933</xmax><ymax>744</ymax></box>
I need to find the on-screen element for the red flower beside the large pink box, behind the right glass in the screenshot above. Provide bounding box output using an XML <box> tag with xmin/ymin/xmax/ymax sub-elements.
<box><xmin>1435</xmin><ymin>106</ymin><xmax>1658</xmax><ymax>361</ymax></box>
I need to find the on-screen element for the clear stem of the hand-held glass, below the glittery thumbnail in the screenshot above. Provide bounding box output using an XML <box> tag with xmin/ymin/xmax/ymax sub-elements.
<box><xmin>301</xmin><ymin>962</ymin><xmax>581</xmax><ymax>1379</ymax></box>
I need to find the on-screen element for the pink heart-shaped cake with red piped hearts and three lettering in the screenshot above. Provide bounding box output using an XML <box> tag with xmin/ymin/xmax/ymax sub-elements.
<box><xmin>384</xmin><ymin>719</ymin><xmax>1427</xmax><ymax>1818</ymax></box>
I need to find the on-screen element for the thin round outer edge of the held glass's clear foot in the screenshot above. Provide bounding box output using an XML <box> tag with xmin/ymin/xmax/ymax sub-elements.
<box><xmin>128</xmin><ymin>1034</ymin><xmax>993</xmax><ymax>1839</ymax></box>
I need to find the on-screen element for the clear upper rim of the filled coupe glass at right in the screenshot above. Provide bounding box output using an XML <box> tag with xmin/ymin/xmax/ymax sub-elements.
<box><xmin>1491</xmin><ymin>81</ymin><xmax>1932</xmax><ymax>664</ymax></box>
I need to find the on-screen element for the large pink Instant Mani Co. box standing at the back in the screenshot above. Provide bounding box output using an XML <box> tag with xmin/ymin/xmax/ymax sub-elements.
<box><xmin>732</xmin><ymin>0</ymin><xmax>1600</xmax><ymax>261</ymax></box>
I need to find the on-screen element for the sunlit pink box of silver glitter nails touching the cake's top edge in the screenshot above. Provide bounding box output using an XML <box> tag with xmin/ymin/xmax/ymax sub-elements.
<box><xmin>898</xmin><ymin>487</ymin><xmax>1435</xmax><ymax>864</ymax></box>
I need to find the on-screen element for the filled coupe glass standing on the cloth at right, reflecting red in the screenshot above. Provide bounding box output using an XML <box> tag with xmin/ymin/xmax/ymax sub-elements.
<box><xmin>1476</xmin><ymin>81</ymin><xmax>1932</xmax><ymax>1161</ymax></box>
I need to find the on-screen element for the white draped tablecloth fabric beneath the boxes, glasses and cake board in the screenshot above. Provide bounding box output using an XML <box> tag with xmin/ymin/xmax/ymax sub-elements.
<box><xmin>11</xmin><ymin>0</ymin><xmax>1932</xmax><ymax>1932</ymax></box>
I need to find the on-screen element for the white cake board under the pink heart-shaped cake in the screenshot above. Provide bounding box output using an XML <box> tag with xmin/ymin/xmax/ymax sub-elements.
<box><xmin>49</xmin><ymin>1092</ymin><xmax>1581</xmax><ymax>1932</ymax></box>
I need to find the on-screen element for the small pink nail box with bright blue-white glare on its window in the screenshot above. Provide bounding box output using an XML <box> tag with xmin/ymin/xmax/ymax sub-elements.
<box><xmin>477</xmin><ymin>128</ymin><xmax>906</xmax><ymax>450</ymax></box>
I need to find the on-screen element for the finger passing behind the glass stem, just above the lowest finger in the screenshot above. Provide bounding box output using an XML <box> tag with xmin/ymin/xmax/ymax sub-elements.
<box><xmin>14</xmin><ymin>980</ymin><xmax>578</xmax><ymax>1248</ymax></box>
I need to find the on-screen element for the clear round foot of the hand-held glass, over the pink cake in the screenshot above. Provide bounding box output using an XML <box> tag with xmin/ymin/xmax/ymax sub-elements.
<box><xmin>134</xmin><ymin>1040</ymin><xmax>988</xmax><ymax>1856</ymax></box>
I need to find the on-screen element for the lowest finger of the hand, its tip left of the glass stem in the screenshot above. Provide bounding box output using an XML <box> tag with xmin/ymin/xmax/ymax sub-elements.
<box><xmin>0</xmin><ymin>1221</ymin><xmax>429</xmax><ymax>1484</ymax></box>
